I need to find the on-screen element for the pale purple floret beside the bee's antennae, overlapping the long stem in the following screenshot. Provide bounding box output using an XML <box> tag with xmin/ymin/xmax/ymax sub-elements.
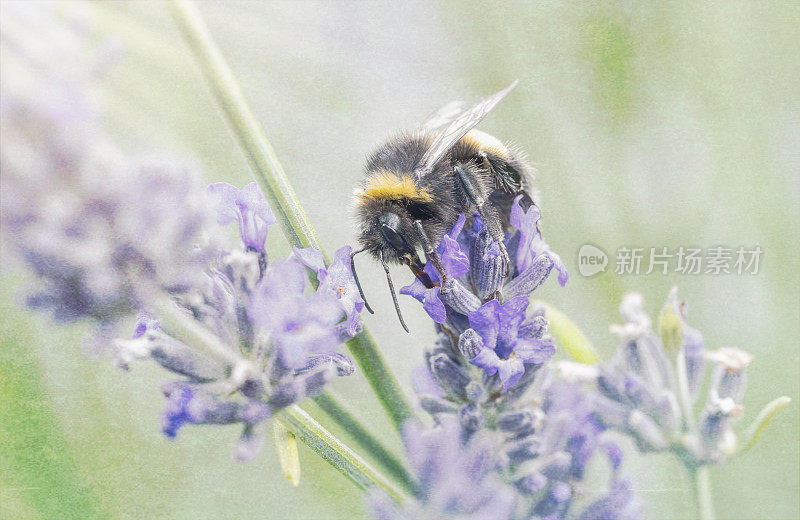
<box><xmin>294</xmin><ymin>246</ymin><xmax>364</xmax><ymax>337</ymax></box>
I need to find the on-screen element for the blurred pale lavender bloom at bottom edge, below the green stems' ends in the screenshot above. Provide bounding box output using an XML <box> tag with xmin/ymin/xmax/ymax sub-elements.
<box><xmin>368</xmin><ymin>418</ymin><xmax>517</xmax><ymax>520</ymax></box>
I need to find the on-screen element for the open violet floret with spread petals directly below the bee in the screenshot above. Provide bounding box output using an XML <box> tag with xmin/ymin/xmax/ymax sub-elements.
<box><xmin>469</xmin><ymin>296</ymin><xmax>555</xmax><ymax>391</ymax></box>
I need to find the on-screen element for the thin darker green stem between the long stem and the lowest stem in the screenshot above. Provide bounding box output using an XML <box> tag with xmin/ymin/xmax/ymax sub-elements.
<box><xmin>313</xmin><ymin>392</ymin><xmax>416</xmax><ymax>493</ymax></box>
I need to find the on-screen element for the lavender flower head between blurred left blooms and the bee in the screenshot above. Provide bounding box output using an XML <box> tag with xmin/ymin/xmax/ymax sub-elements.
<box><xmin>110</xmin><ymin>201</ymin><xmax>354</xmax><ymax>459</ymax></box>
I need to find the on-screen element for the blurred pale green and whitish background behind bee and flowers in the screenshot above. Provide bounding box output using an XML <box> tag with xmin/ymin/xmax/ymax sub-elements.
<box><xmin>0</xmin><ymin>0</ymin><xmax>800</xmax><ymax>519</ymax></box>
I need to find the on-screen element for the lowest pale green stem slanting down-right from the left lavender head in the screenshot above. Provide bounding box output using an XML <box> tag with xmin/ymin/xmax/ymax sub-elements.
<box><xmin>276</xmin><ymin>405</ymin><xmax>406</xmax><ymax>502</ymax></box>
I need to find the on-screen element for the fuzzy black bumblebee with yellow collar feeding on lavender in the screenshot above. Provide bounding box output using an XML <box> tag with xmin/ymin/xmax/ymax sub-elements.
<box><xmin>350</xmin><ymin>81</ymin><xmax>534</xmax><ymax>331</ymax></box>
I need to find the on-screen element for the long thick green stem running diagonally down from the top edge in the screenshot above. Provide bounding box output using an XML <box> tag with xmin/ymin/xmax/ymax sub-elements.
<box><xmin>169</xmin><ymin>0</ymin><xmax>413</xmax><ymax>429</ymax></box>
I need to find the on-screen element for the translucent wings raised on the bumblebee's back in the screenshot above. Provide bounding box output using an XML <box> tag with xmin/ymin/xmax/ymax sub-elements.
<box><xmin>416</xmin><ymin>81</ymin><xmax>517</xmax><ymax>178</ymax></box>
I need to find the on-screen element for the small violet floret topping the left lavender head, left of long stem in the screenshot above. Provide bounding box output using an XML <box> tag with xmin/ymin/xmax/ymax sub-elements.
<box><xmin>208</xmin><ymin>182</ymin><xmax>278</xmax><ymax>252</ymax></box>
